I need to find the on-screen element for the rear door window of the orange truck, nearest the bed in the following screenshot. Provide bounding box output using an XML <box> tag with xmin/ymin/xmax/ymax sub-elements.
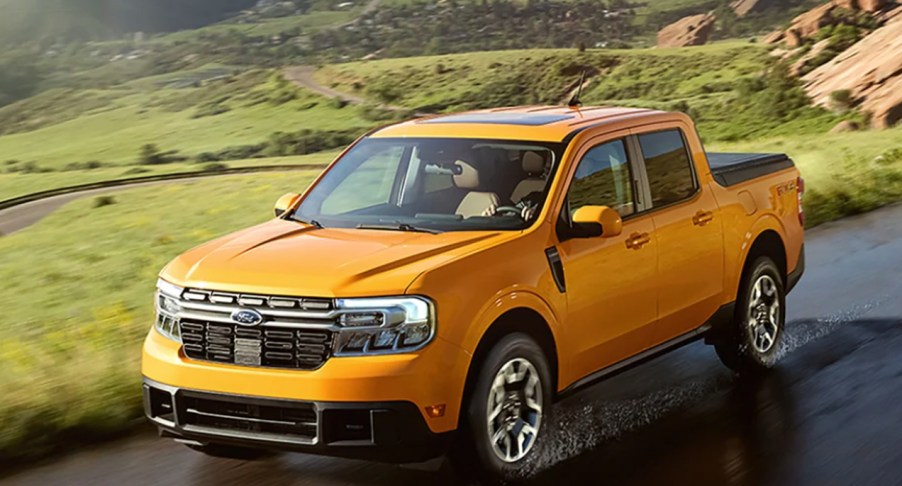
<box><xmin>639</xmin><ymin>130</ymin><xmax>696</xmax><ymax>207</ymax></box>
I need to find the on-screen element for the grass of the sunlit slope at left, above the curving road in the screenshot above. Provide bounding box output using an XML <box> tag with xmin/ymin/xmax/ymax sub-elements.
<box><xmin>0</xmin><ymin>68</ymin><xmax>373</xmax><ymax>170</ymax></box>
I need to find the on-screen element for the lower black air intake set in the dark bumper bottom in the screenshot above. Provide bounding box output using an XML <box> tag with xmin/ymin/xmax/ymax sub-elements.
<box><xmin>176</xmin><ymin>391</ymin><xmax>318</xmax><ymax>443</ymax></box>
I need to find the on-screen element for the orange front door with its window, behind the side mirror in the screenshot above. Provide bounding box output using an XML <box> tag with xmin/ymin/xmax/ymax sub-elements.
<box><xmin>559</xmin><ymin>134</ymin><xmax>658</xmax><ymax>384</ymax></box>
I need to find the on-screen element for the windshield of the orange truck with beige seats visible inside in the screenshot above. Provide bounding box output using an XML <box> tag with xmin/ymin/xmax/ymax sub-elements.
<box><xmin>292</xmin><ymin>138</ymin><xmax>561</xmax><ymax>231</ymax></box>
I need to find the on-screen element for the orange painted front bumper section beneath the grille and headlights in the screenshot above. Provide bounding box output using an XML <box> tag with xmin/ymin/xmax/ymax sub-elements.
<box><xmin>141</xmin><ymin>330</ymin><xmax>470</xmax><ymax>434</ymax></box>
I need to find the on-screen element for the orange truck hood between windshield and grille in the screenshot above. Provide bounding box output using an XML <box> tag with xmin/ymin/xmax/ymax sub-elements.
<box><xmin>161</xmin><ymin>219</ymin><xmax>519</xmax><ymax>297</ymax></box>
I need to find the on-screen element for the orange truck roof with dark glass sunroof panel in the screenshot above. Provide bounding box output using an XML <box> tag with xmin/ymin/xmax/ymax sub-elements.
<box><xmin>370</xmin><ymin>106</ymin><xmax>685</xmax><ymax>142</ymax></box>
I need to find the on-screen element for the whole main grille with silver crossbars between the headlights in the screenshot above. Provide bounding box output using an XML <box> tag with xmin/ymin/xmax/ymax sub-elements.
<box><xmin>157</xmin><ymin>289</ymin><xmax>337</xmax><ymax>370</ymax></box>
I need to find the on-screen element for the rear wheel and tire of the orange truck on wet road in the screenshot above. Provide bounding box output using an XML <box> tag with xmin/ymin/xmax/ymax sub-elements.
<box><xmin>714</xmin><ymin>256</ymin><xmax>786</xmax><ymax>376</ymax></box>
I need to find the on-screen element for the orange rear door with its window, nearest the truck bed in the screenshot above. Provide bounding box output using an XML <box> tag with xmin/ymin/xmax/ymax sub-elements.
<box><xmin>632</xmin><ymin>122</ymin><xmax>724</xmax><ymax>343</ymax></box>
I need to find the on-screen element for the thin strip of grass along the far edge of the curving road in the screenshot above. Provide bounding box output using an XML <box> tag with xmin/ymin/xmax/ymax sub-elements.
<box><xmin>0</xmin><ymin>152</ymin><xmax>338</xmax><ymax>201</ymax></box>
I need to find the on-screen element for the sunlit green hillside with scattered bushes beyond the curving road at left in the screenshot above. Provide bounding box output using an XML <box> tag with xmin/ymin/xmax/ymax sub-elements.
<box><xmin>0</xmin><ymin>70</ymin><xmax>378</xmax><ymax>172</ymax></box>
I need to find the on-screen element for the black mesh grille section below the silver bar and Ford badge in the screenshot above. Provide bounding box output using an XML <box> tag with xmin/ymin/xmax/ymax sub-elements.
<box><xmin>180</xmin><ymin>319</ymin><xmax>332</xmax><ymax>370</ymax></box>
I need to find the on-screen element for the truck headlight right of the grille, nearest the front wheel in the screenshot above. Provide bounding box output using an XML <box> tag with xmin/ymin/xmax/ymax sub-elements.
<box><xmin>335</xmin><ymin>297</ymin><xmax>435</xmax><ymax>356</ymax></box>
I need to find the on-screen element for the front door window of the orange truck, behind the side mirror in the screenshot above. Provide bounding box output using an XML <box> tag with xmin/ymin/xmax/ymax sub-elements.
<box><xmin>567</xmin><ymin>140</ymin><xmax>636</xmax><ymax>216</ymax></box>
